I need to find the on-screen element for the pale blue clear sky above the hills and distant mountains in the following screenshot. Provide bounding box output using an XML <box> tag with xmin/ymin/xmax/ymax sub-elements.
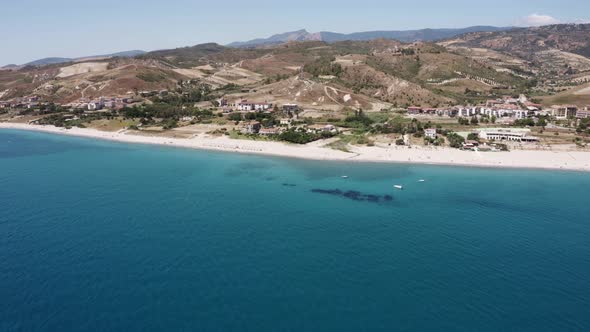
<box><xmin>0</xmin><ymin>0</ymin><xmax>590</xmax><ymax>66</ymax></box>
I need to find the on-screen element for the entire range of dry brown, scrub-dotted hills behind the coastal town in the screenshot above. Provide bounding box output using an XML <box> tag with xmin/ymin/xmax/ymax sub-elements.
<box><xmin>0</xmin><ymin>25</ymin><xmax>590</xmax><ymax>111</ymax></box>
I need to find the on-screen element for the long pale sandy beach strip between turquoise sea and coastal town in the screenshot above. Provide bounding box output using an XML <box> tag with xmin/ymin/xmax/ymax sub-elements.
<box><xmin>0</xmin><ymin>122</ymin><xmax>590</xmax><ymax>172</ymax></box>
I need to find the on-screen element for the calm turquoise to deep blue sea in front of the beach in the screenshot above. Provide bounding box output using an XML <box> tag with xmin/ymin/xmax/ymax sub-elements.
<box><xmin>0</xmin><ymin>130</ymin><xmax>590</xmax><ymax>332</ymax></box>
